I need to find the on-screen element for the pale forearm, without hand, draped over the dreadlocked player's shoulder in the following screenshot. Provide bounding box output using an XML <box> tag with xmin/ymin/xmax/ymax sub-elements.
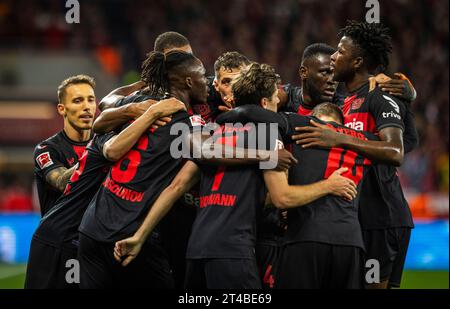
<box><xmin>103</xmin><ymin>109</ymin><xmax>161</xmax><ymax>162</ymax></box>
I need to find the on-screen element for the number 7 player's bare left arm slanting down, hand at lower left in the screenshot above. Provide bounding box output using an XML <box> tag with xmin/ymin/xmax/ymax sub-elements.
<box><xmin>114</xmin><ymin>161</ymin><xmax>200</xmax><ymax>266</ymax></box>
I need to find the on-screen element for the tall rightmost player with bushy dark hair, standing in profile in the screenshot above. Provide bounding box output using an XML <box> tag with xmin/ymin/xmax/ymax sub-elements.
<box><xmin>300</xmin><ymin>22</ymin><xmax>414</xmax><ymax>288</ymax></box>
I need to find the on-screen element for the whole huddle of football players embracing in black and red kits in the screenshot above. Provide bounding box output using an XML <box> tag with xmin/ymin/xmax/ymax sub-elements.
<box><xmin>25</xmin><ymin>21</ymin><xmax>418</xmax><ymax>289</ymax></box>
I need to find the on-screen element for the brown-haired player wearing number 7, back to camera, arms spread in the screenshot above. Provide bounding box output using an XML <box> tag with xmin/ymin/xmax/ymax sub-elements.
<box><xmin>111</xmin><ymin>63</ymin><xmax>356</xmax><ymax>288</ymax></box>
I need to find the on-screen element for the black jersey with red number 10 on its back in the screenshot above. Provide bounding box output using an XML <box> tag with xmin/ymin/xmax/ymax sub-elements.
<box><xmin>285</xmin><ymin>114</ymin><xmax>377</xmax><ymax>249</ymax></box>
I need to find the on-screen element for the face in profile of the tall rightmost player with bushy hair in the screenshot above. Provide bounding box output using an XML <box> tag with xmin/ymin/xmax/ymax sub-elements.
<box><xmin>331</xmin><ymin>36</ymin><xmax>355</xmax><ymax>82</ymax></box>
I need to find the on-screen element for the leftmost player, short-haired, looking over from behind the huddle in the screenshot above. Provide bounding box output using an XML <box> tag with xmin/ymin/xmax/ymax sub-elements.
<box><xmin>34</xmin><ymin>75</ymin><xmax>97</xmax><ymax>216</ymax></box>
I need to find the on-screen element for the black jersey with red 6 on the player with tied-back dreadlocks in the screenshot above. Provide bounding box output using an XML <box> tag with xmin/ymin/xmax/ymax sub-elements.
<box><xmin>79</xmin><ymin>96</ymin><xmax>204</xmax><ymax>242</ymax></box>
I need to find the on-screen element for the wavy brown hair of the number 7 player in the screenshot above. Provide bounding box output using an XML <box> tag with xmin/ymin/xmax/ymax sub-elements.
<box><xmin>232</xmin><ymin>63</ymin><xmax>279</xmax><ymax>106</ymax></box>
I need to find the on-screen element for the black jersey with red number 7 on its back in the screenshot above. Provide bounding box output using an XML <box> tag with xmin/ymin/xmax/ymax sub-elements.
<box><xmin>186</xmin><ymin>113</ymin><xmax>281</xmax><ymax>259</ymax></box>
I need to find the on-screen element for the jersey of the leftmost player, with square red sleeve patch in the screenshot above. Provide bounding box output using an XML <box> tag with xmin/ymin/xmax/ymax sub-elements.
<box><xmin>34</xmin><ymin>131</ymin><xmax>88</xmax><ymax>216</ymax></box>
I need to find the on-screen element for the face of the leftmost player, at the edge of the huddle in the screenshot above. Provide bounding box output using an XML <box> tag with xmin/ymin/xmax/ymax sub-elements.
<box><xmin>58</xmin><ymin>84</ymin><xmax>97</xmax><ymax>130</ymax></box>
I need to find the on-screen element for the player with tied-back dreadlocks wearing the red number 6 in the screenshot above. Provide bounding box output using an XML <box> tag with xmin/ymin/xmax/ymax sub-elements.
<box><xmin>78</xmin><ymin>51</ymin><xmax>208</xmax><ymax>288</ymax></box>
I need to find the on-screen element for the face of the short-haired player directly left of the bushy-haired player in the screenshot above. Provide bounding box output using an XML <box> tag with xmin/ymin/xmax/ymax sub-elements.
<box><xmin>303</xmin><ymin>54</ymin><xmax>337</xmax><ymax>104</ymax></box>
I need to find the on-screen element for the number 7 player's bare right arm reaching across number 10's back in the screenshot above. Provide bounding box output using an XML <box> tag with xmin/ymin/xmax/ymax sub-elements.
<box><xmin>264</xmin><ymin>168</ymin><xmax>357</xmax><ymax>209</ymax></box>
